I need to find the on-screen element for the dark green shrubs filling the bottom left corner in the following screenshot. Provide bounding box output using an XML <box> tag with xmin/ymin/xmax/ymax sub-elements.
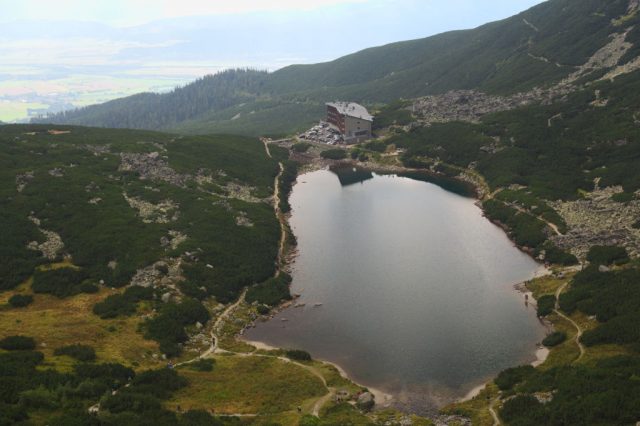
<box><xmin>0</xmin><ymin>340</ymin><xmax>234</xmax><ymax>426</ymax></box>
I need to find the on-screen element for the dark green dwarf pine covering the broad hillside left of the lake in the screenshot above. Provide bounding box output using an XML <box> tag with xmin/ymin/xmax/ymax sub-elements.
<box><xmin>0</xmin><ymin>126</ymin><xmax>278</xmax><ymax>302</ymax></box>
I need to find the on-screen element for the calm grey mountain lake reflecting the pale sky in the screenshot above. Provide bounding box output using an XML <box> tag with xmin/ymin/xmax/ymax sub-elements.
<box><xmin>246</xmin><ymin>171</ymin><xmax>545</xmax><ymax>413</ymax></box>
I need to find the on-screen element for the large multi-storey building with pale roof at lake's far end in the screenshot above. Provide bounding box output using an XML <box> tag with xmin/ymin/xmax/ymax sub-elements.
<box><xmin>327</xmin><ymin>102</ymin><xmax>373</xmax><ymax>144</ymax></box>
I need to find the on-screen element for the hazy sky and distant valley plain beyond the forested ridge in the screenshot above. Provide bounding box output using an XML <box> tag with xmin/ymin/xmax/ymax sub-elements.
<box><xmin>0</xmin><ymin>0</ymin><xmax>541</xmax><ymax>122</ymax></box>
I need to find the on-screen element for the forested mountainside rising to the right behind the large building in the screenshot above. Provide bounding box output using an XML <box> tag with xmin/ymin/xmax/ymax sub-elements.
<box><xmin>40</xmin><ymin>0</ymin><xmax>640</xmax><ymax>134</ymax></box>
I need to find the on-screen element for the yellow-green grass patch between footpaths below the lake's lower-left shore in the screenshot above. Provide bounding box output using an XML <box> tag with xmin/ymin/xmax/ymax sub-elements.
<box><xmin>168</xmin><ymin>356</ymin><xmax>327</xmax><ymax>414</ymax></box>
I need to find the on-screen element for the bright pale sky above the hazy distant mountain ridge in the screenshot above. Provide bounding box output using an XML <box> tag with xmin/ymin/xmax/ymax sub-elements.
<box><xmin>6</xmin><ymin>0</ymin><xmax>541</xmax><ymax>30</ymax></box>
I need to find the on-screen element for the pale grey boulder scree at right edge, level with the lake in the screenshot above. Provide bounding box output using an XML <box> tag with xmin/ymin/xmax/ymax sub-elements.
<box><xmin>550</xmin><ymin>187</ymin><xmax>640</xmax><ymax>260</ymax></box>
